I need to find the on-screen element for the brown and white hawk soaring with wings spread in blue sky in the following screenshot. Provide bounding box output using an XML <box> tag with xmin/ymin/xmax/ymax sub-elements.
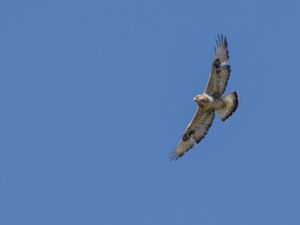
<box><xmin>170</xmin><ymin>35</ymin><xmax>239</xmax><ymax>160</ymax></box>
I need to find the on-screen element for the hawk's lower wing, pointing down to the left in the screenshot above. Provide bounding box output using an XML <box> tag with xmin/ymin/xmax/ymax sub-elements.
<box><xmin>170</xmin><ymin>108</ymin><xmax>215</xmax><ymax>160</ymax></box>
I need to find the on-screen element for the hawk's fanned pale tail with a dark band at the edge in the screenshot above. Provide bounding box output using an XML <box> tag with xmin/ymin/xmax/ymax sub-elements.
<box><xmin>217</xmin><ymin>91</ymin><xmax>239</xmax><ymax>121</ymax></box>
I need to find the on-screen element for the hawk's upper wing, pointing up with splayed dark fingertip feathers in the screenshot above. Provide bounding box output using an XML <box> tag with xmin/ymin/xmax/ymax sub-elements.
<box><xmin>205</xmin><ymin>35</ymin><xmax>230</xmax><ymax>97</ymax></box>
